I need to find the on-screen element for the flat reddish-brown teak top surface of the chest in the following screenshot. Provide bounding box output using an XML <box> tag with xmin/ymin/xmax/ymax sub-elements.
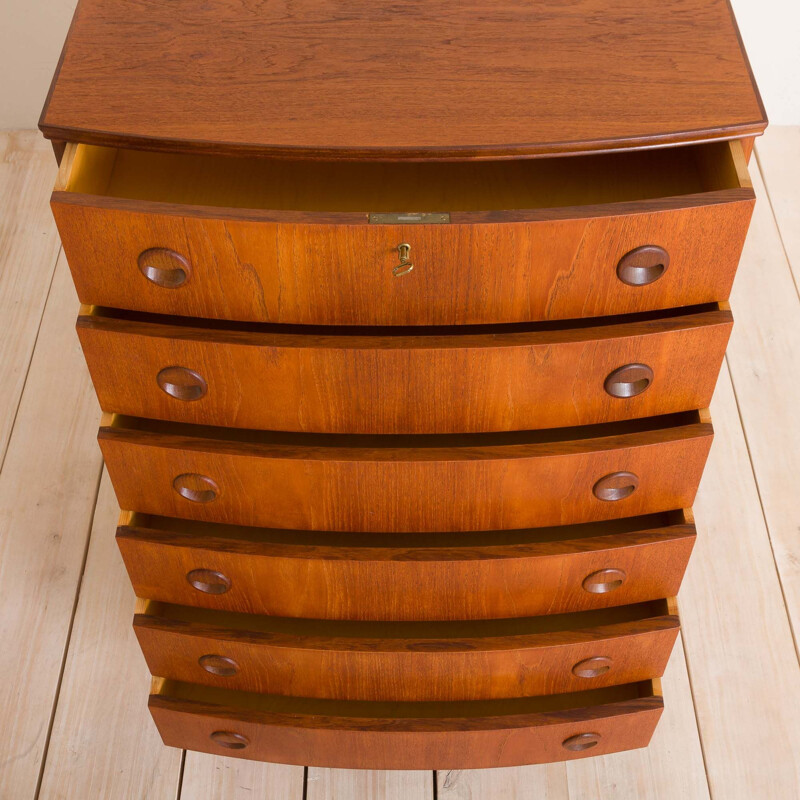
<box><xmin>40</xmin><ymin>0</ymin><xmax>766</xmax><ymax>159</ymax></box>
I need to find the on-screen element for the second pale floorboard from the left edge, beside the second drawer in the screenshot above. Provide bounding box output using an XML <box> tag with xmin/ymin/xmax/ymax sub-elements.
<box><xmin>0</xmin><ymin>258</ymin><xmax>101</xmax><ymax>800</ymax></box>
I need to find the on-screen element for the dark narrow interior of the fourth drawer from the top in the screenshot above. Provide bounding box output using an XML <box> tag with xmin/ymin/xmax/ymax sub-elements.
<box><xmin>122</xmin><ymin>509</ymin><xmax>694</xmax><ymax>561</ymax></box>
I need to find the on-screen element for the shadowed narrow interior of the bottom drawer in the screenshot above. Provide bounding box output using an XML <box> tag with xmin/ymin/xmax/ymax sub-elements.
<box><xmin>153</xmin><ymin>680</ymin><xmax>655</xmax><ymax>719</ymax></box>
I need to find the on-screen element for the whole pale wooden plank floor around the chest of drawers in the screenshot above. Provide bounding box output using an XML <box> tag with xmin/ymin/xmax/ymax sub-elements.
<box><xmin>0</xmin><ymin>128</ymin><xmax>800</xmax><ymax>800</ymax></box>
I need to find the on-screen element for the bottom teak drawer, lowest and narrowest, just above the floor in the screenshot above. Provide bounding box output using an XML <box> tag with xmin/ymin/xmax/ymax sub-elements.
<box><xmin>149</xmin><ymin>678</ymin><xmax>664</xmax><ymax>769</ymax></box>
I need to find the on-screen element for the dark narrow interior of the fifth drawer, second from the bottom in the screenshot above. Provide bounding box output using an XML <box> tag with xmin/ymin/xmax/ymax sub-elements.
<box><xmin>137</xmin><ymin>599</ymin><xmax>677</xmax><ymax>650</ymax></box>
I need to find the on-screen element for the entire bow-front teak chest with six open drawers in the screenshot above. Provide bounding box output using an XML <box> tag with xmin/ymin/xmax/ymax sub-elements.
<box><xmin>41</xmin><ymin>0</ymin><xmax>766</xmax><ymax>769</ymax></box>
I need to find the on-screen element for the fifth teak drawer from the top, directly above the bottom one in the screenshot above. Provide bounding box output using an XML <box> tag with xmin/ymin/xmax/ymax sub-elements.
<box><xmin>133</xmin><ymin>586</ymin><xmax>679</xmax><ymax>702</ymax></box>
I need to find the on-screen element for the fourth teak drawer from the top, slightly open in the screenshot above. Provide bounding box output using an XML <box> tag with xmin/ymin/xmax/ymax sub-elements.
<box><xmin>117</xmin><ymin>509</ymin><xmax>696</xmax><ymax>621</ymax></box>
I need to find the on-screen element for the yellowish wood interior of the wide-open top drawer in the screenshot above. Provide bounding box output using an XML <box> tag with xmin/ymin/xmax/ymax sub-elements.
<box><xmin>56</xmin><ymin>141</ymin><xmax>749</xmax><ymax>213</ymax></box>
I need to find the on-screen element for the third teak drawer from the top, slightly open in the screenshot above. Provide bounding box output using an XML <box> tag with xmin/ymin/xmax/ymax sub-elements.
<box><xmin>99</xmin><ymin>411</ymin><xmax>713</xmax><ymax>532</ymax></box>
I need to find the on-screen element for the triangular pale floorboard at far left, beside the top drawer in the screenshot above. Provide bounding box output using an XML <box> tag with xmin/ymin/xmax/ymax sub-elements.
<box><xmin>0</xmin><ymin>131</ymin><xmax>60</xmax><ymax>464</ymax></box>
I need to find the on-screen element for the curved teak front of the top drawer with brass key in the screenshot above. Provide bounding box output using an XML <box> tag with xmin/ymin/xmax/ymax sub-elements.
<box><xmin>52</xmin><ymin>192</ymin><xmax>754</xmax><ymax>325</ymax></box>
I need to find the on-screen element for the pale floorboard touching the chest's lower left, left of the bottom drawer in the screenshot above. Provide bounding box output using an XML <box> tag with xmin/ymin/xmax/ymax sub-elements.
<box><xmin>39</xmin><ymin>472</ymin><xmax>183</xmax><ymax>800</ymax></box>
